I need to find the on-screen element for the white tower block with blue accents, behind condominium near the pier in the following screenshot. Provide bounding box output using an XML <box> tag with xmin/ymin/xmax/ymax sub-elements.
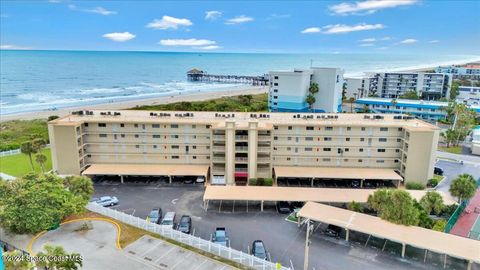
<box><xmin>268</xmin><ymin>68</ymin><xmax>343</xmax><ymax>112</ymax></box>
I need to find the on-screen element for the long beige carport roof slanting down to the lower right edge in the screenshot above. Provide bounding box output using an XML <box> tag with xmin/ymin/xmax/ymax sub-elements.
<box><xmin>298</xmin><ymin>202</ymin><xmax>480</xmax><ymax>262</ymax></box>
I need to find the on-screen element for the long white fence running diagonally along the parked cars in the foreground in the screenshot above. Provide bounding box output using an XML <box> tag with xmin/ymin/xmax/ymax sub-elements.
<box><xmin>87</xmin><ymin>203</ymin><xmax>290</xmax><ymax>270</ymax></box>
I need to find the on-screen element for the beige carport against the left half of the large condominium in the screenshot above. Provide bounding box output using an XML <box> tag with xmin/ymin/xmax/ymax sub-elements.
<box><xmin>82</xmin><ymin>164</ymin><xmax>209</xmax><ymax>183</ymax></box>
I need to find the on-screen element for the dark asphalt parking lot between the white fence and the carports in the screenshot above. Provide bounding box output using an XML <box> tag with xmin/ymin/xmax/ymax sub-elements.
<box><xmin>91</xmin><ymin>181</ymin><xmax>464</xmax><ymax>270</ymax></box>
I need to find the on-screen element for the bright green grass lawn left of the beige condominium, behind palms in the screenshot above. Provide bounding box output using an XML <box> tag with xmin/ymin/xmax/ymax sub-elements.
<box><xmin>0</xmin><ymin>148</ymin><xmax>52</xmax><ymax>177</ymax></box>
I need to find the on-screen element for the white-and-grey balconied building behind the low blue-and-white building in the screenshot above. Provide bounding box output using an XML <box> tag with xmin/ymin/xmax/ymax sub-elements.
<box><xmin>369</xmin><ymin>72</ymin><xmax>452</xmax><ymax>100</ymax></box>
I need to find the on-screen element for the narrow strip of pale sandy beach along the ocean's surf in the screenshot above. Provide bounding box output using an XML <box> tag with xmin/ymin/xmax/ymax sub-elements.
<box><xmin>0</xmin><ymin>86</ymin><xmax>268</xmax><ymax>122</ymax></box>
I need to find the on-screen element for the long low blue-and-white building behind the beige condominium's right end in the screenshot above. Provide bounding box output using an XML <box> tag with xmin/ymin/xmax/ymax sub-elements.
<box><xmin>356</xmin><ymin>98</ymin><xmax>480</xmax><ymax>122</ymax></box>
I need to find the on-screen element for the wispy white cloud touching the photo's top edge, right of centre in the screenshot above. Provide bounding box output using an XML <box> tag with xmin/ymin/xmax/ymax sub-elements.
<box><xmin>328</xmin><ymin>0</ymin><xmax>418</xmax><ymax>15</ymax></box>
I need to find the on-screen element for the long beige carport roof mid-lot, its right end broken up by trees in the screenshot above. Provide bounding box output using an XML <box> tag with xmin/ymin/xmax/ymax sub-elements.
<box><xmin>203</xmin><ymin>185</ymin><xmax>456</xmax><ymax>205</ymax></box>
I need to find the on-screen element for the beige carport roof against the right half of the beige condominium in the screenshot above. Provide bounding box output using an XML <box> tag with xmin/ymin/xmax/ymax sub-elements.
<box><xmin>274</xmin><ymin>166</ymin><xmax>403</xmax><ymax>181</ymax></box>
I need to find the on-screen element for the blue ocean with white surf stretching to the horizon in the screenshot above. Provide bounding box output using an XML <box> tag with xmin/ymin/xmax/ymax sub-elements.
<box><xmin>0</xmin><ymin>50</ymin><xmax>480</xmax><ymax>115</ymax></box>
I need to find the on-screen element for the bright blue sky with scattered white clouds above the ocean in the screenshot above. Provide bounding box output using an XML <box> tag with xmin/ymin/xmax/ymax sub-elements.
<box><xmin>0</xmin><ymin>0</ymin><xmax>480</xmax><ymax>54</ymax></box>
